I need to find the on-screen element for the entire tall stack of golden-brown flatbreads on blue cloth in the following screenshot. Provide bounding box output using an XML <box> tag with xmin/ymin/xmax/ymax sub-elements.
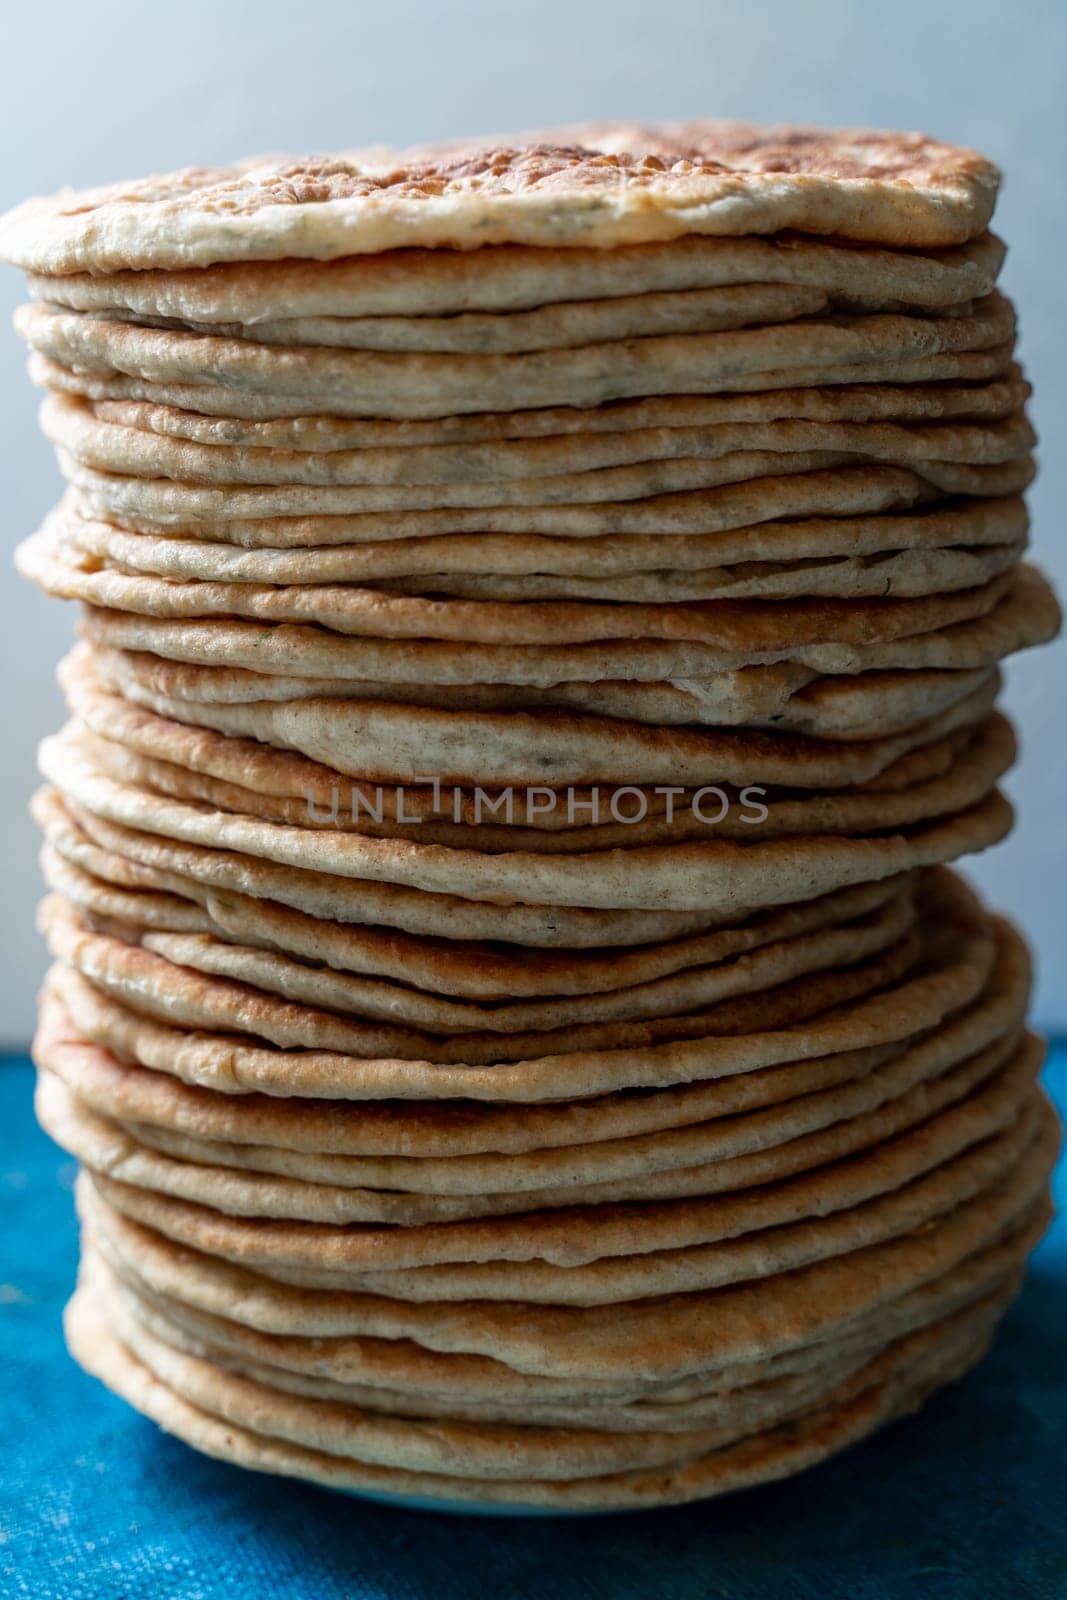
<box><xmin>0</xmin><ymin>123</ymin><xmax>1059</xmax><ymax>1510</ymax></box>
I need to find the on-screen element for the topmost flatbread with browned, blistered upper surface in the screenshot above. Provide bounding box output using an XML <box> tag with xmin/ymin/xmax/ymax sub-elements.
<box><xmin>0</xmin><ymin>122</ymin><xmax>1000</xmax><ymax>274</ymax></box>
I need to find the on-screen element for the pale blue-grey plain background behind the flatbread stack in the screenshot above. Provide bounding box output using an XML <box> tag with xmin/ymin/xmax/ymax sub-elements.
<box><xmin>0</xmin><ymin>0</ymin><xmax>1067</xmax><ymax>1046</ymax></box>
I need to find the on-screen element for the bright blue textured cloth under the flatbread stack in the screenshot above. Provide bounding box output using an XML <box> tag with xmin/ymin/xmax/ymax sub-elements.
<box><xmin>0</xmin><ymin>1043</ymin><xmax>1067</xmax><ymax>1600</ymax></box>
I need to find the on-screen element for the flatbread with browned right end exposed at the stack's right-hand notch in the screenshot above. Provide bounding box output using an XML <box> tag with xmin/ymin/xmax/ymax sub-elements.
<box><xmin>35</xmin><ymin>880</ymin><xmax>995</xmax><ymax>1104</ymax></box>
